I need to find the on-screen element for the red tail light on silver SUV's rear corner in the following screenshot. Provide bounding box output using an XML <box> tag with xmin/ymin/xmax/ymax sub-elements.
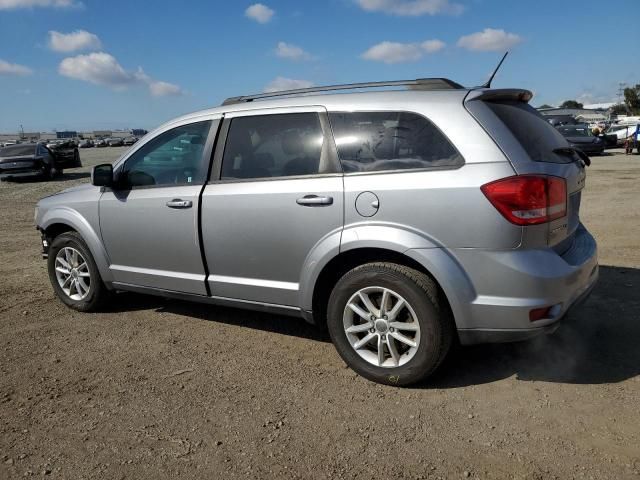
<box><xmin>480</xmin><ymin>175</ymin><xmax>567</xmax><ymax>225</ymax></box>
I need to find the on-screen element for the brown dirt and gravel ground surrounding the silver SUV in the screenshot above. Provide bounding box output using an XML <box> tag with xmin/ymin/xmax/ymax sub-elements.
<box><xmin>0</xmin><ymin>148</ymin><xmax>640</xmax><ymax>479</ymax></box>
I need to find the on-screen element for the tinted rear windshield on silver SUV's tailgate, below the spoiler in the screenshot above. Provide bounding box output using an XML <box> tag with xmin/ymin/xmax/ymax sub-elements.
<box><xmin>486</xmin><ymin>102</ymin><xmax>576</xmax><ymax>163</ymax></box>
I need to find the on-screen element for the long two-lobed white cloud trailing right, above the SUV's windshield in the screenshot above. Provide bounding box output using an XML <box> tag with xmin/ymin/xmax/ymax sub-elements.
<box><xmin>58</xmin><ymin>52</ymin><xmax>184</xmax><ymax>97</ymax></box>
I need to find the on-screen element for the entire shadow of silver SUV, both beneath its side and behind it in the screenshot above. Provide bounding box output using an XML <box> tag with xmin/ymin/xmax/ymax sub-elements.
<box><xmin>106</xmin><ymin>266</ymin><xmax>640</xmax><ymax>389</ymax></box>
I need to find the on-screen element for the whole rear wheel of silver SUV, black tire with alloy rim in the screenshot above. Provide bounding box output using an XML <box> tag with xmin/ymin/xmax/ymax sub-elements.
<box><xmin>327</xmin><ymin>263</ymin><xmax>453</xmax><ymax>386</ymax></box>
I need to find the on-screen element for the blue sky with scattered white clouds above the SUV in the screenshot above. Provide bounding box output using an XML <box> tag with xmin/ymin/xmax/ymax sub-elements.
<box><xmin>0</xmin><ymin>0</ymin><xmax>640</xmax><ymax>132</ymax></box>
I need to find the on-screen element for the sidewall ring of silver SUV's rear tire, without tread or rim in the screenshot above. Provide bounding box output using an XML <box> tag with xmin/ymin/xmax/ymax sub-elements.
<box><xmin>327</xmin><ymin>267</ymin><xmax>443</xmax><ymax>386</ymax></box>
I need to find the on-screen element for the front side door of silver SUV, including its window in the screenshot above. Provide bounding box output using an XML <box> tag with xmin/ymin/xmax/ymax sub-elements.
<box><xmin>100</xmin><ymin>119</ymin><xmax>219</xmax><ymax>295</ymax></box>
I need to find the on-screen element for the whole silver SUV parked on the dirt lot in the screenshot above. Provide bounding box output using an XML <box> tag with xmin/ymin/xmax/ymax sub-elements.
<box><xmin>36</xmin><ymin>79</ymin><xmax>598</xmax><ymax>385</ymax></box>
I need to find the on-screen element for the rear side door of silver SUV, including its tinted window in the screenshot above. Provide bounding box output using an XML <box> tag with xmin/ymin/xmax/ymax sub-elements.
<box><xmin>202</xmin><ymin>107</ymin><xmax>343</xmax><ymax>307</ymax></box>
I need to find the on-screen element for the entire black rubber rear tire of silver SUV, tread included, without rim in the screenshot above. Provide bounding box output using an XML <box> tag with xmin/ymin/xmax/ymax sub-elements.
<box><xmin>327</xmin><ymin>263</ymin><xmax>454</xmax><ymax>386</ymax></box>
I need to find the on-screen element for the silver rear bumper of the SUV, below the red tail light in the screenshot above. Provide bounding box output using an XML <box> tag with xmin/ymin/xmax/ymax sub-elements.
<box><xmin>455</xmin><ymin>225</ymin><xmax>598</xmax><ymax>344</ymax></box>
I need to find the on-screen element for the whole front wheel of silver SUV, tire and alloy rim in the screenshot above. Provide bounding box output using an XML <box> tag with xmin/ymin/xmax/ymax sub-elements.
<box><xmin>47</xmin><ymin>232</ymin><xmax>108</xmax><ymax>312</ymax></box>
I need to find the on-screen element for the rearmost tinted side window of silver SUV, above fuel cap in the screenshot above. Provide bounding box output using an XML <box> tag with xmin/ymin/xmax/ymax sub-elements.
<box><xmin>329</xmin><ymin>112</ymin><xmax>464</xmax><ymax>173</ymax></box>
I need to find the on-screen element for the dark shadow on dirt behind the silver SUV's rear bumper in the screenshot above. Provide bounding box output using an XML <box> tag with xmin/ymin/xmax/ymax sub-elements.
<box><xmin>430</xmin><ymin>266</ymin><xmax>640</xmax><ymax>388</ymax></box>
